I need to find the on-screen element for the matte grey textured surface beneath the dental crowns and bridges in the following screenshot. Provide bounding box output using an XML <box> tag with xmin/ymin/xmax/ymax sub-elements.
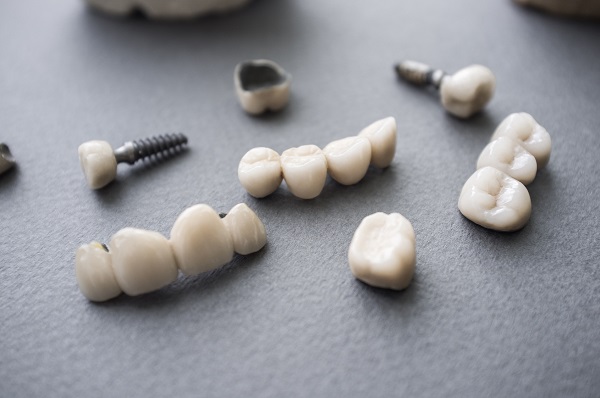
<box><xmin>0</xmin><ymin>0</ymin><xmax>600</xmax><ymax>397</ymax></box>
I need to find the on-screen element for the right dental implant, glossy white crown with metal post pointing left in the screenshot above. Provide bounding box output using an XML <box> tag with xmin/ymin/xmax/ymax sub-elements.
<box><xmin>395</xmin><ymin>61</ymin><xmax>496</xmax><ymax>119</ymax></box>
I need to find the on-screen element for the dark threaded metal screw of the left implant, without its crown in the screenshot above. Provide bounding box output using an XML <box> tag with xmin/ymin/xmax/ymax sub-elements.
<box><xmin>114</xmin><ymin>133</ymin><xmax>188</xmax><ymax>164</ymax></box>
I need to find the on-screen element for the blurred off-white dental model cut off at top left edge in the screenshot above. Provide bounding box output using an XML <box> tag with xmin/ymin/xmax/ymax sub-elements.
<box><xmin>86</xmin><ymin>0</ymin><xmax>249</xmax><ymax>19</ymax></box>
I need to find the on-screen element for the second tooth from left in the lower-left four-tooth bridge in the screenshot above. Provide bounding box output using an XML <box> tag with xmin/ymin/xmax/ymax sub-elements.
<box><xmin>109</xmin><ymin>228</ymin><xmax>179</xmax><ymax>296</ymax></box>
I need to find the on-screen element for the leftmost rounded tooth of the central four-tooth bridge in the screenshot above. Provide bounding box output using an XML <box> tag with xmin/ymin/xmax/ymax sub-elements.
<box><xmin>238</xmin><ymin>147</ymin><xmax>283</xmax><ymax>198</ymax></box>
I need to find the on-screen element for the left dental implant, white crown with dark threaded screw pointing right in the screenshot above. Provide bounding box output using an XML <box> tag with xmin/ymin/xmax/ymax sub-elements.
<box><xmin>78</xmin><ymin>133</ymin><xmax>188</xmax><ymax>189</ymax></box>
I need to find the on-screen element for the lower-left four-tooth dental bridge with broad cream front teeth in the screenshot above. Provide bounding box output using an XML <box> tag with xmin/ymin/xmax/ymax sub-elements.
<box><xmin>75</xmin><ymin>203</ymin><xmax>267</xmax><ymax>301</ymax></box>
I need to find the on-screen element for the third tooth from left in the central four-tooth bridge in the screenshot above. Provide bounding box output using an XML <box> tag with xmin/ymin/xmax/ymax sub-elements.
<box><xmin>323</xmin><ymin>137</ymin><xmax>371</xmax><ymax>185</ymax></box>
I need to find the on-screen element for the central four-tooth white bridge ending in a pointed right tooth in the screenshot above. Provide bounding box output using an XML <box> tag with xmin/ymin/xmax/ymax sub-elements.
<box><xmin>238</xmin><ymin>117</ymin><xmax>397</xmax><ymax>199</ymax></box>
